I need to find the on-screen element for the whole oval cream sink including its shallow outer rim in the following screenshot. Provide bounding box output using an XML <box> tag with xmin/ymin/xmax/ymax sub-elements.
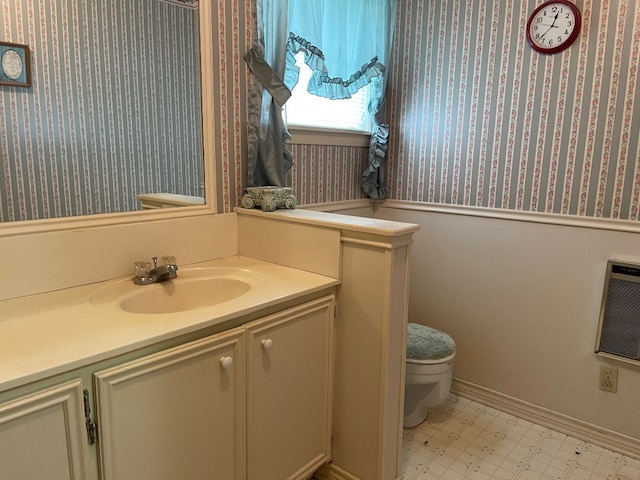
<box><xmin>89</xmin><ymin>267</ymin><xmax>266</xmax><ymax>314</ymax></box>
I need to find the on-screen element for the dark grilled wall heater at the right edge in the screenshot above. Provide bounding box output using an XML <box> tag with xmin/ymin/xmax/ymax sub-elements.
<box><xmin>596</xmin><ymin>260</ymin><xmax>640</xmax><ymax>363</ymax></box>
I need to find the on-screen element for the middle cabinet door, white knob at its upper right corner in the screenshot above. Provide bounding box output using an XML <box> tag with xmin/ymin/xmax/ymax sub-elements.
<box><xmin>95</xmin><ymin>329</ymin><xmax>246</xmax><ymax>480</ymax></box>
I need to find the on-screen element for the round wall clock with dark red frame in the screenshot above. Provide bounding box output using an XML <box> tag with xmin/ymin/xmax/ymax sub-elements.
<box><xmin>527</xmin><ymin>0</ymin><xmax>580</xmax><ymax>53</ymax></box>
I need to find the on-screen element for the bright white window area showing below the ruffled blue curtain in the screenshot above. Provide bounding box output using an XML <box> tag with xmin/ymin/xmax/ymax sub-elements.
<box><xmin>283</xmin><ymin>51</ymin><xmax>373</xmax><ymax>135</ymax></box>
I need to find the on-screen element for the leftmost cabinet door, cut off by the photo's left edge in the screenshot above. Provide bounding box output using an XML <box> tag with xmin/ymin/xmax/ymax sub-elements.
<box><xmin>0</xmin><ymin>380</ymin><xmax>87</xmax><ymax>480</ymax></box>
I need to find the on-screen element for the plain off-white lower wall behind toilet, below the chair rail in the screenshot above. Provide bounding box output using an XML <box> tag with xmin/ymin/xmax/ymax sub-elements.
<box><xmin>376</xmin><ymin>202</ymin><xmax>640</xmax><ymax>439</ymax></box>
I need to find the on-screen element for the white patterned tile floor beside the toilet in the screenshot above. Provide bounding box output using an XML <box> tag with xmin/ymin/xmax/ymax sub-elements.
<box><xmin>402</xmin><ymin>395</ymin><xmax>640</xmax><ymax>480</ymax></box>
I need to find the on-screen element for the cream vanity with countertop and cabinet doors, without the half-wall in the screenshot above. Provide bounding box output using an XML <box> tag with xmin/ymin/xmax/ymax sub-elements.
<box><xmin>0</xmin><ymin>257</ymin><xmax>337</xmax><ymax>480</ymax></box>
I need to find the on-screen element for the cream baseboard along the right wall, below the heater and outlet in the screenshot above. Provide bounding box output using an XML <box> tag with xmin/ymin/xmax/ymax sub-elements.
<box><xmin>451</xmin><ymin>378</ymin><xmax>640</xmax><ymax>459</ymax></box>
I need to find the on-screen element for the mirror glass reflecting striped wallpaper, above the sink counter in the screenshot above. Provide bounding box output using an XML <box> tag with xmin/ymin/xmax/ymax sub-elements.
<box><xmin>0</xmin><ymin>0</ymin><xmax>204</xmax><ymax>222</ymax></box>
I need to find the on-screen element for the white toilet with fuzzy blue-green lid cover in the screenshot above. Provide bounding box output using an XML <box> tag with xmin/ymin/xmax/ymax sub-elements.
<box><xmin>402</xmin><ymin>323</ymin><xmax>456</xmax><ymax>428</ymax></box>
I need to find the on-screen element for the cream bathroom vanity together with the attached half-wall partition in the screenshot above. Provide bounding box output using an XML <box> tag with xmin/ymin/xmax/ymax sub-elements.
<box><xmin>0</xmin><ymin>210</ymin><xmax>417</xmax><ymax>480</ymax></box>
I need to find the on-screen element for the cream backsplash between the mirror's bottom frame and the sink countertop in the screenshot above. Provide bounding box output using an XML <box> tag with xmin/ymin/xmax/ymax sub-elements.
<box><xmin>0</xmin><ymin>214</ymin><xmax>238</xmax><ymax>301</ymax></box>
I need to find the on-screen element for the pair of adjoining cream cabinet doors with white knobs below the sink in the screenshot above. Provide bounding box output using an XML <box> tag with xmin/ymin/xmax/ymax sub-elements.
<box><xmin>94</xmin><ymin>296</ymin><xmax>334</xmax><ymax>480</ymax></box>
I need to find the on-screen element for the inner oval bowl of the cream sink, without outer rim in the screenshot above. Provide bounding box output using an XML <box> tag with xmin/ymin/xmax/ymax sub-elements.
<box><xmin>120</xmin><ymin>278</ymin><xmax>251</xmax><ymax>313</ymax></box>
